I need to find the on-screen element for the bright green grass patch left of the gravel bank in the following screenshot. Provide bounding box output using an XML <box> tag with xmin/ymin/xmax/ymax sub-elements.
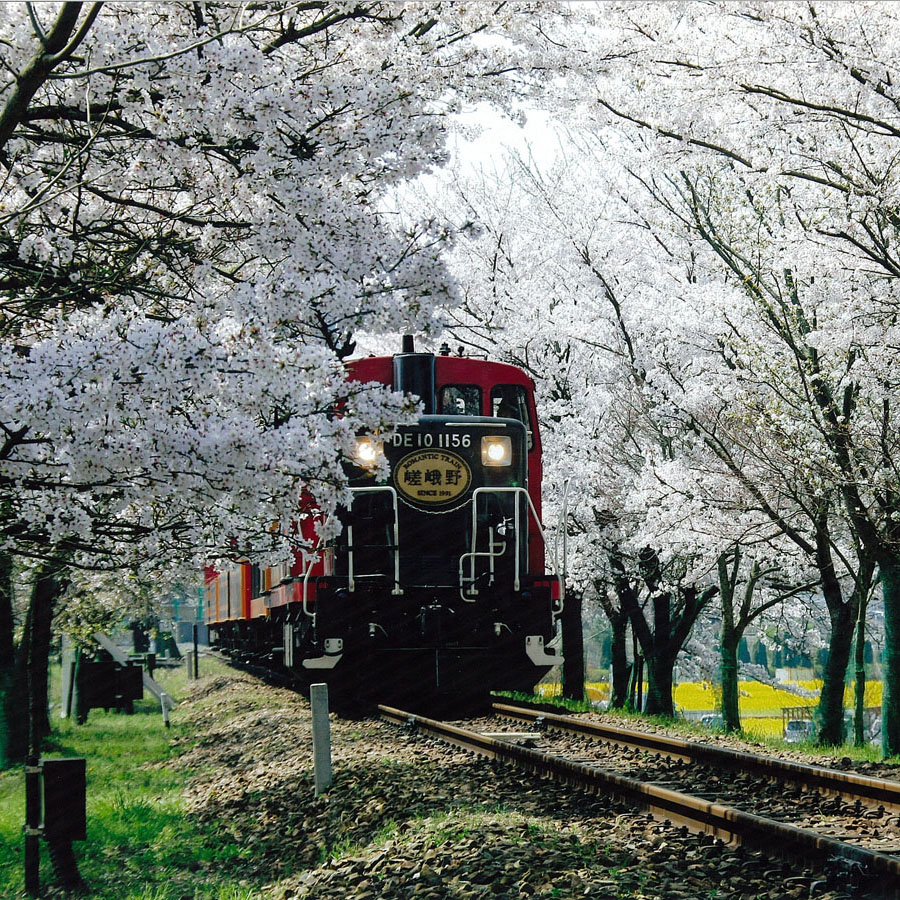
<box><xmin>0</xmin><ymin>660</ymin><xmax>268</xmax><ymax>900</ymax></box>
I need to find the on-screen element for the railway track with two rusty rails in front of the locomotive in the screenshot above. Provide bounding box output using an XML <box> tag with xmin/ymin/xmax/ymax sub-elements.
<box><xmin>379</xmin><ymin>704</ymin><xmax>900</xmax><ymax>897</ymax></box>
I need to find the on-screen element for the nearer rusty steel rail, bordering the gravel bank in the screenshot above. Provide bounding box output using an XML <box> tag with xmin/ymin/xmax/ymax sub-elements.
<box><xmin>378</xmin><ymin>706</ymin><xmax>900</xmax><ymax>884</ymax></box>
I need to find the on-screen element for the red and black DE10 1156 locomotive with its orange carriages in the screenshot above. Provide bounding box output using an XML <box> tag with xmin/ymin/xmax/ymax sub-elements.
<box><xmin>205</xmin><ymin>337</ymin><xmax>563</xmax><ymax>703</ymax></box>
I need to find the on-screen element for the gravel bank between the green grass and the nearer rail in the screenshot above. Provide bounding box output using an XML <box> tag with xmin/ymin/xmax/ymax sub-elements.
<box><xmin>167</xmin><ymin>672</ymin><xmax>872</xmax><ymax>900</ymax></box>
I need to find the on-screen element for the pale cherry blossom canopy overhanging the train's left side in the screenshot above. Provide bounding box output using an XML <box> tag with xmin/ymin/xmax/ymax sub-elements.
<box><xmin>0</xmin><ymin>2</ymin><xmax>561</xmax><ymax>764</ymax></box>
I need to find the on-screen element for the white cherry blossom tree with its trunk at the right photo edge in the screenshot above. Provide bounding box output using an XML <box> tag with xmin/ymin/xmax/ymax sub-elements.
<box><xmin>568</xmin><ymin>4</ymin><xmax>900</xmax><ymax>753</ymax></box>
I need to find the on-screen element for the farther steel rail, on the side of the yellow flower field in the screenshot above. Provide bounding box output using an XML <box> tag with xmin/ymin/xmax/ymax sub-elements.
<box><xmin>493</xmin><ymin>703</ymin><xmax>900</xmax><ymax>809</ymax></box>
